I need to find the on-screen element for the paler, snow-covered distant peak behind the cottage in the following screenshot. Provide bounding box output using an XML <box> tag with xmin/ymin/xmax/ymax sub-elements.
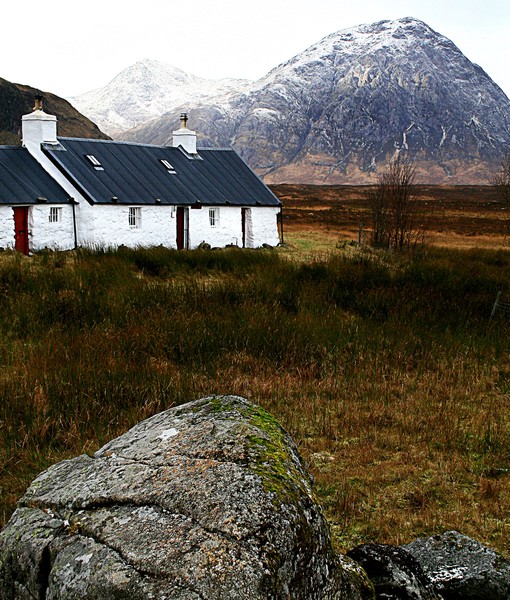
<box><xmin>70</xmin><ymin>59</ymin><xmax>249</xmax><ymax>136</ymax></box>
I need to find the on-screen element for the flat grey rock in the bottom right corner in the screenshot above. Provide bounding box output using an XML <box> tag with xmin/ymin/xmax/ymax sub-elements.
<box><xmin>403</xmin><ymin>531</ymin><xmax>510</xmax><ymax>600</ymax></box>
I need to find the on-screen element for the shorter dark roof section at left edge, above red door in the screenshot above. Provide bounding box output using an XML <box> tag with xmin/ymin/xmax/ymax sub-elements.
<box><xmin>0</xmin><ymin>146</ymin><xmax>69</xmax><ymax>205</ymax></box>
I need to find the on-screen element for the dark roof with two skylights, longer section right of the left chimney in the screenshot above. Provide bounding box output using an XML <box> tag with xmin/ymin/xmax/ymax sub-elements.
<box><xmin>44</xmin><ymin>138</ymin><xmax>280</xmax><ymax>206</ymax></box>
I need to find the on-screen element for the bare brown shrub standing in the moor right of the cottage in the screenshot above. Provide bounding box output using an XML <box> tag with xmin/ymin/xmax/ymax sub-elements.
<box><xmin>368</xmin><ymin>158</ymin><xmax>423</xmax><ymax>252</ymax></box>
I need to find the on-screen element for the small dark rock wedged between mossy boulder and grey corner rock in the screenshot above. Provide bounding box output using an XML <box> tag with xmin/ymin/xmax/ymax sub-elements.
<box><xmin>347</xmin><ymin>544</ymin><xmax>441</xmax><ymax>600</ymax></box>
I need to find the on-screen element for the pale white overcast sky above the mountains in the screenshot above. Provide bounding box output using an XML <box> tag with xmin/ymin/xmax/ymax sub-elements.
<box><xmin>0</xmin><ymin>0</ymin><xmax>510</xmax><ymax>97</ymax></box>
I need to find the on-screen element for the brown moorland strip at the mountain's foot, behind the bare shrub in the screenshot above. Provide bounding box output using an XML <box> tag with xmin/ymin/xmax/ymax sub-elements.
<box><xmin>271</xmin><ymin>184</ymin><xmax>510</xmax><ymax>248</ymax></box>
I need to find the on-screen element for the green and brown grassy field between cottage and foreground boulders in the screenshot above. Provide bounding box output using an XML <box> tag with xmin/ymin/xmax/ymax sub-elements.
<box><xmin>0</xmin><ymin>231</ymin><xmax>510</xmax><ymax>554</ymax></box>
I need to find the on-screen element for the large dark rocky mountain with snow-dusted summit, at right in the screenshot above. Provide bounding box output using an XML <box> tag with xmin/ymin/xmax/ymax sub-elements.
<box><xmin>117</xmin><ymin>18</ymin><xmax>510</xmax><ymax>184</ymax></box>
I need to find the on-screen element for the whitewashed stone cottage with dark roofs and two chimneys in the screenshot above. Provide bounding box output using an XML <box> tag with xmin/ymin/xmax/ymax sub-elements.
<box><xmin>0</xmin><ymin>98</ymin><xmax>281</xmax><ymax>253</ymax></box>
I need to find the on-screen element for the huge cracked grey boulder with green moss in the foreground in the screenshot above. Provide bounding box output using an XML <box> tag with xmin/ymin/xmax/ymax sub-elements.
<box><xmin>0</xmin><ymin>396</ymin><xmax>373</xmax><ymax>600</ymax></box>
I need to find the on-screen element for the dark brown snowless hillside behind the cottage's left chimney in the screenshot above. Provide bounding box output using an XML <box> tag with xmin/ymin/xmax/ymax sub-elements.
<box><xmin>0</xmin><ymin>78</ymin><xmax>110</xmax><ymax>145</ymax></box>
